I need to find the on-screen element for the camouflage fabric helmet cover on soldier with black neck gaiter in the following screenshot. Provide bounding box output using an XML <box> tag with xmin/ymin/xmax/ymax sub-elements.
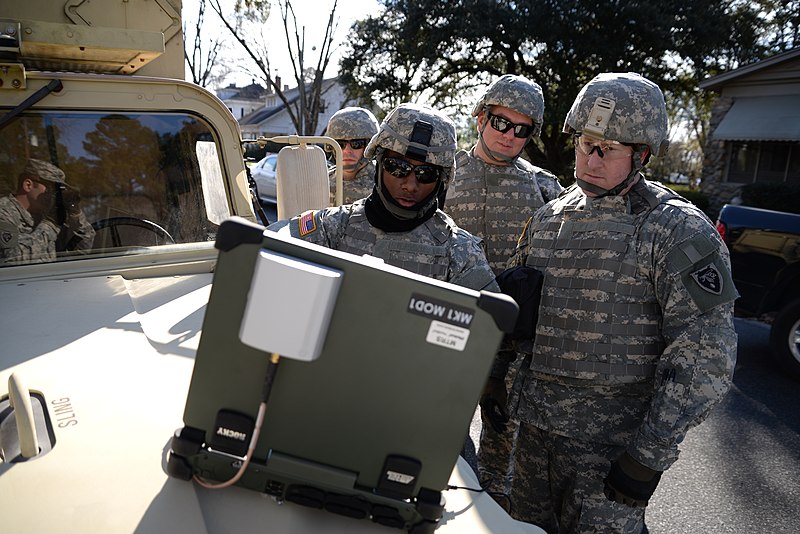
<box><xmin>364</xmin><ymin>104</ymin><xmax>456</xmax><ymax>184</ymax></box>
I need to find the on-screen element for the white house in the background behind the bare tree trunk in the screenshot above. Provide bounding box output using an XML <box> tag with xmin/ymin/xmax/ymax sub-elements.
<box><xmin>233</xmin><ymin>78</ymin><xmax>352</xmax><ymax>139</ymax></box>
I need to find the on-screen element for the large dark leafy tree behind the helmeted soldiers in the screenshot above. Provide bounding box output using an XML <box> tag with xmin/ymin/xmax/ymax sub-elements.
<box><xmin>341</xmin><ymin>0</ymin><xmax>759</xmax><ymax>182</ymax></box>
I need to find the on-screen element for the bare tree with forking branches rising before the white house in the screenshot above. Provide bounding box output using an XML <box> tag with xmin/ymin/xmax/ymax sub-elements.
<box><xmin>209</xmin><ymin>0</ymin><xmax>338</xmax><ymax>135</ymax></box>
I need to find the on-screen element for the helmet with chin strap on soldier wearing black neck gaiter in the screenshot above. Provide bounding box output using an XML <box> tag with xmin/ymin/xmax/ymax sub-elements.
<box><xmin>364</xmin><ymin>103</ymin><xmax>456</xmax><ymax>220</ymax></box>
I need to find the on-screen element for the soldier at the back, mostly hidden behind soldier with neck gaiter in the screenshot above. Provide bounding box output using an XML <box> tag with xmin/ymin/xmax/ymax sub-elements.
<box><xmin>325</xmin><ymin>107</ymin><xmax>378</xmax><ymax>206</ymax></box>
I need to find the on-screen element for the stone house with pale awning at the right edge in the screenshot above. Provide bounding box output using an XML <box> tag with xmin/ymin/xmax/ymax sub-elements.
<box><xmin>700</xmin><ymin>48</ymin><xmax>800</xmax><ymax>218</ymax></box>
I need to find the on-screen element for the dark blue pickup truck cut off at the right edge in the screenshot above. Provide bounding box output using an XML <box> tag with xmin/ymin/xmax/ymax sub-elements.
<box><xmin>717</xmin><ymin>204</ymin><xmax>800</xmax><ymax>379</ymax></box>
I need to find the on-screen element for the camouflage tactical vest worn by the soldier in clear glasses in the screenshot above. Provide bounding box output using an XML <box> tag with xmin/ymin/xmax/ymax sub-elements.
<box><xmin>526</xmin><ymin>184</ymin><xmax>677</xmax><ymax>384</ymax></box>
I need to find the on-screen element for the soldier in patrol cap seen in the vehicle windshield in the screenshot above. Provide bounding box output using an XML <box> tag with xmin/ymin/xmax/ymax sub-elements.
<box><xmin>0</xmin><ymin>159</ymin><xmax>95</xmax><ymax>265</ymax></box>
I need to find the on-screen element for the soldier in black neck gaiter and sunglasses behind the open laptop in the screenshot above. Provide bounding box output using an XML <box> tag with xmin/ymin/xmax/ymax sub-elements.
<box><xmin>276</xmin><ymin>104</ymin><xmax>499</xmax><ymax>291</ymax></box>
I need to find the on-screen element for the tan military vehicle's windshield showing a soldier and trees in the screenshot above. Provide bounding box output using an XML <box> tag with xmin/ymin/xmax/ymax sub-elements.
<box><xmin>0</xmin><ymin>111</ymin><xmax>228</xmax><ymax>266</ymax></box>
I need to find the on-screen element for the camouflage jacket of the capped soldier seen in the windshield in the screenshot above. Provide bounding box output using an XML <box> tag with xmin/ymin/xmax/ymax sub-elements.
<box><xmin>0</xmin><ymin>195</ymin><xmax>95</xmax><ymax>264</ymax></box>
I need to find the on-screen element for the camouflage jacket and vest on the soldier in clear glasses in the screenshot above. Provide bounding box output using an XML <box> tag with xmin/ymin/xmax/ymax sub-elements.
<box><xmin>512</xmin><ymin>178</ymin><xmax>738</xmax><ymax>471</ymax></box>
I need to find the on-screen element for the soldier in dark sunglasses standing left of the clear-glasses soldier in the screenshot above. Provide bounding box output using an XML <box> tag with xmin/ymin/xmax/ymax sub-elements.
<box><xmin>445</xmin><ymin>74</ymin><xmax>563</xmax><ymax>509</ymax></box>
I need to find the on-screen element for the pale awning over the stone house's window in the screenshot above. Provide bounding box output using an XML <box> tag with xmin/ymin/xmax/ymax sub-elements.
<box><xmin>712</xmin><ymin>95</ymin><xmax>800</xmax><ymax>141</ymax></box>
